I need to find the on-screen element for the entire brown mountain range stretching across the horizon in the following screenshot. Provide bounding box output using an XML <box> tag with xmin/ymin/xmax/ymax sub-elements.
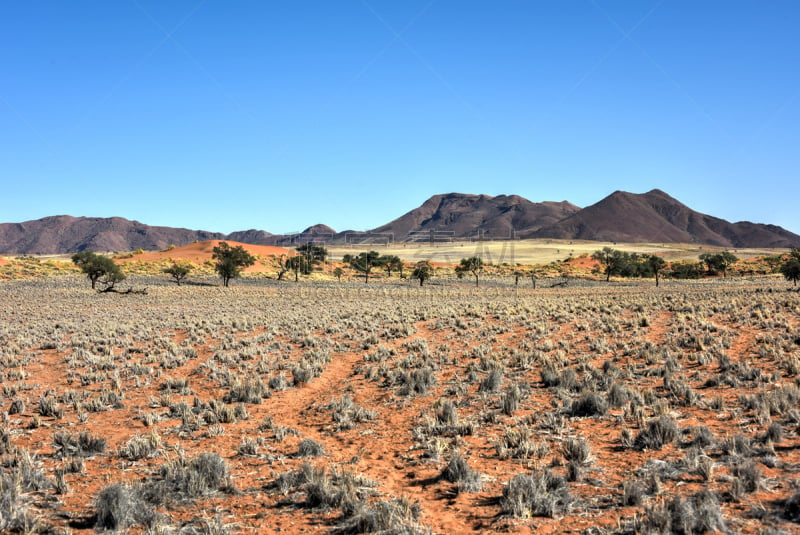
<box><xmin>0</xmin><ymin>189</ymin><xmax>800</xmax><ymax>254</ymax></box>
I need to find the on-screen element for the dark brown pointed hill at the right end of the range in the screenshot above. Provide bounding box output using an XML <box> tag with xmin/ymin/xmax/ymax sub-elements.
<box><xmin>533</xmin><ymin>189</ymin><xmax>800</xmax><ymax>247</ymax></box>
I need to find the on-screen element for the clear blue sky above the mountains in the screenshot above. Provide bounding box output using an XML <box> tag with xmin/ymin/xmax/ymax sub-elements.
<box><xmin>0</xmin><ymin>0</ymin><xmax>800</xmax><ymax>233</ymax></box>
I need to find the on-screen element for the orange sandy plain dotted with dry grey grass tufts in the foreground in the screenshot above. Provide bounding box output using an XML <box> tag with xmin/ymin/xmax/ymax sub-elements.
<box><xmin>0</xmin><ymin>275</ymin><xmax>800</xmax><ymax>534</ymax></box>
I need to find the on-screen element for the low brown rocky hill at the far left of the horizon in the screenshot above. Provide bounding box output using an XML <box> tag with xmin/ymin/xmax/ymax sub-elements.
<box><xmin>0</xmin><ymin>215</ymin><xmax>225</xmax><ymax>254</ymax></box>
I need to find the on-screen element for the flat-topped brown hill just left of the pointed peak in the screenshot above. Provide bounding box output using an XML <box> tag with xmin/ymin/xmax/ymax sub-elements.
<box><xmin>371</xmin><ymin>193</ymin><xmax>579</xmax><ymax>241</ymax></box>
